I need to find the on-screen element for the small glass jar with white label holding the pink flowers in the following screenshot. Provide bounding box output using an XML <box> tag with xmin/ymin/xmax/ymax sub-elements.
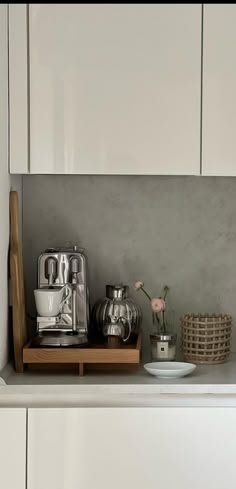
<box><xmin>150</xmin><ymin>311</ymin><xmax>177</xmax><ymax>362</ymax></box>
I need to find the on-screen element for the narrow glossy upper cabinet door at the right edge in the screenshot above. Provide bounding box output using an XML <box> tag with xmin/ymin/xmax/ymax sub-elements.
<box><xmin>202</xmin><ymin>4</ymin><xmax>236</xmax><ymax>176</ymax></box>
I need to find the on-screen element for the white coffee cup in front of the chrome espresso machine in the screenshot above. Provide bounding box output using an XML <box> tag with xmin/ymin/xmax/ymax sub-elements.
<box><xmin>34</xmin><ymin>285</ymin><xmax>71</xmax><ymax>317</ymax></box>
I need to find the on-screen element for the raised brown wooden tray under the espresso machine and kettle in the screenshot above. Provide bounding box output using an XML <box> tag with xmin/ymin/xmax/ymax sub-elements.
<box><xmin>23</xmin><ymin>333</ymin><xmax>142</xmax><ymax>375</ymax></box>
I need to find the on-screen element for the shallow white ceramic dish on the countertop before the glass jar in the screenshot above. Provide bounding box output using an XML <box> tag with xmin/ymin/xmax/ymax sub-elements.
<box><xmin>144</xmin><ymin>362</ymin><xmax>196</xmax><ymax>379</ymax></box>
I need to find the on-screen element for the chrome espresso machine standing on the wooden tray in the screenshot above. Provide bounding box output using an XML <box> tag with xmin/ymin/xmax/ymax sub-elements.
<box><xmin>33</xmin><ymin>246</ymin><xmax>89</xmax><ymax>347</ymax></box>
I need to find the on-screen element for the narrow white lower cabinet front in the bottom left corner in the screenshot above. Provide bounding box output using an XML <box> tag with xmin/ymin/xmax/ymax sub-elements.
<box><xmin>0</xmin><ymin>408</ymin><xmax>26</xmax><ymax>489</ymax></box>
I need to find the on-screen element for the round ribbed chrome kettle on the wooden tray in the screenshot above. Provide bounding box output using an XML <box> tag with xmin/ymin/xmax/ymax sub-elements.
<box><xmin>92</xmin><ymin>285</ymin><xmax>142</xmax><ymax>343</ymax></box>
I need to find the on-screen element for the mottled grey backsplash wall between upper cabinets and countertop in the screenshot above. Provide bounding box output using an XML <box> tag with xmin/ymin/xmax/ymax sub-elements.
<box><xmin>23</xmin><ymin>175</ymin><xmax>236</xmax><ymax>351</ymax></box>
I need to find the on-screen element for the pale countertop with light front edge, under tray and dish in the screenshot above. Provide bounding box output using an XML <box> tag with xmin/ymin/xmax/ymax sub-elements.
<box><xmin>0</xmin><ymin>354</ymin><xmax>236</xmax><ymax>407</ymax></box>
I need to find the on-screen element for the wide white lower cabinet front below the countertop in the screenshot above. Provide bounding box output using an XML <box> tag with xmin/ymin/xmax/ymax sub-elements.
<box><xmin>27</xmin><ymin>408</ymin><xmax>236</xmax><ymax>489</ymax></box>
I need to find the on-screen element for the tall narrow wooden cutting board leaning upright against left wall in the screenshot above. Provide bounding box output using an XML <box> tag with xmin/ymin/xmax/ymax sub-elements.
<box><xmin>10</xmin><ymin>191</ymin><xmax>27</xmax><ymax>372</ymax></box>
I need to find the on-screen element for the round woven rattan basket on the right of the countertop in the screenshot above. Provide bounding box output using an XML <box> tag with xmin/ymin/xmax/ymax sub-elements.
<box><xmin>181</xmin><ymin>314</ymin><xmax>232</xmax><ymax>364</ymax></box>
